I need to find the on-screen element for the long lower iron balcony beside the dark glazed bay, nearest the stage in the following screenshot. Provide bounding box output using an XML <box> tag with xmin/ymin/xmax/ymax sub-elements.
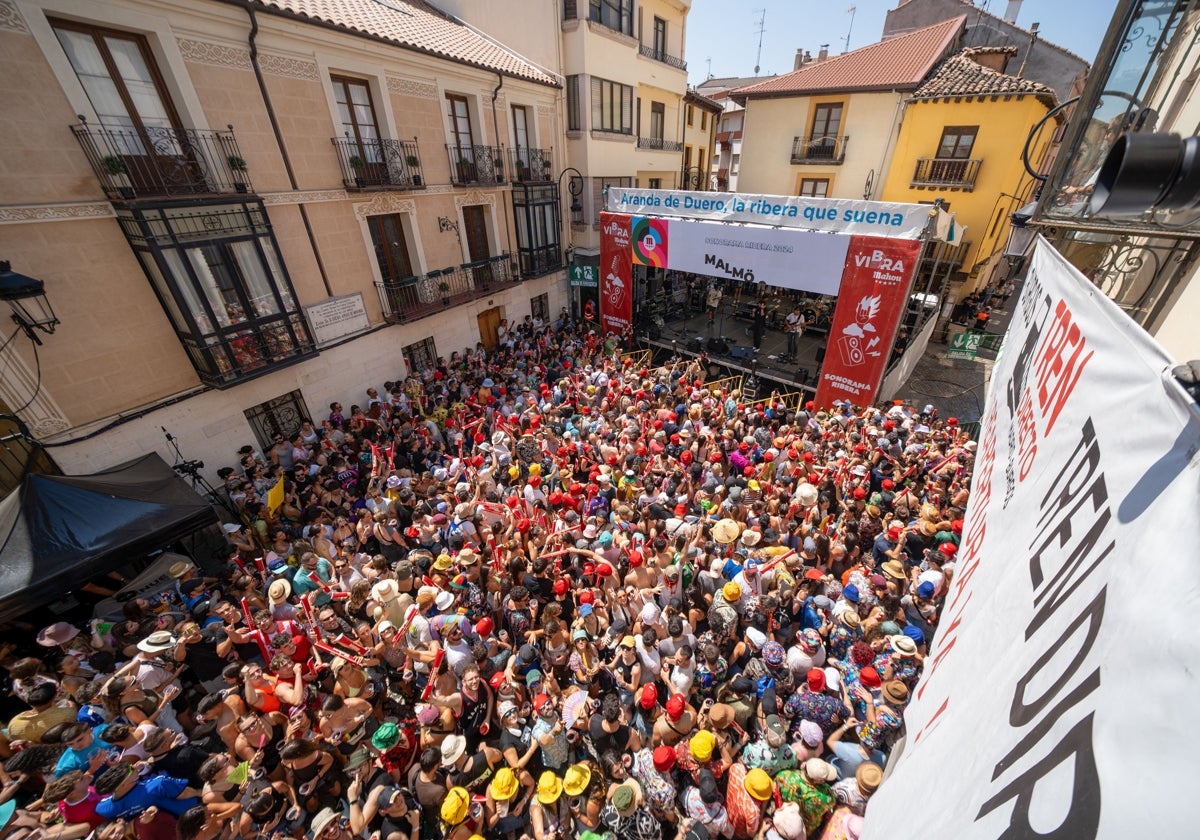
<box><xmin>376</xmin><ymin>253</ymin><xmax>514</xmax><ymax>324</ymax></box>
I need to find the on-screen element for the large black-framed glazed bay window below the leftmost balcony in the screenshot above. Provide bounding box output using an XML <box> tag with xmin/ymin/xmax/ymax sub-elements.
<box><xmin>118</xmin><ymin>202</ymin><xmax>316</xmax><ymax>388</ymax></box>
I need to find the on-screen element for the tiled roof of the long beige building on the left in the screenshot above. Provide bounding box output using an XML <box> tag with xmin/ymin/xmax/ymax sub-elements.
<box><xmin>254</xmin><ymin>0</ymin><xmax>559</xmax><ymax>88</ymax></box>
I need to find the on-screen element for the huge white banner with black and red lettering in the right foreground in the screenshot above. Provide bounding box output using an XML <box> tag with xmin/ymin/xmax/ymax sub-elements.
<box><xmin>863</xmin><ymin>238</ymin><xmax>1200</xmax><ymax>840</ymax></box>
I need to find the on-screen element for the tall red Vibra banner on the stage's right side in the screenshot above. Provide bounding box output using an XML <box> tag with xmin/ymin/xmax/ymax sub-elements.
<box><xmin>816</xmin><ymin>236</ymin><xmax>920</xmax><ymax>408</ymax></box>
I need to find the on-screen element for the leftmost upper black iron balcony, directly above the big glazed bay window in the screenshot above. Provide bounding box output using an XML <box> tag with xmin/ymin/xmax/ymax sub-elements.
<box><xmin>71</xmin><ymin>118</ymin><xmax>252</xmax><ymax>202</ymax></box>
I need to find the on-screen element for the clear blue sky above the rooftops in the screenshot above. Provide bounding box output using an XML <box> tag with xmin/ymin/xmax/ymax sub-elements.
<box><xmin>686</xmin><ymin>0</ymin><xmax>1117</xmax><ymax>85</ymax></box>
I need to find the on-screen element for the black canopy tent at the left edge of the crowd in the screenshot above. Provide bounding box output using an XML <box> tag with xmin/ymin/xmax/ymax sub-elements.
<box><xmin>0</xmin><ymin>454</ymin><xmax>217</xmax><ymax>620</ymax></box>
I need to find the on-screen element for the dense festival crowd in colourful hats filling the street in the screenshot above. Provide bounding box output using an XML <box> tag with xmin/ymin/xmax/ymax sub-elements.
<box><xmin>0</xmin><ymin>319</ymin><xmax>974</xmax><ymax>840</ymax></box>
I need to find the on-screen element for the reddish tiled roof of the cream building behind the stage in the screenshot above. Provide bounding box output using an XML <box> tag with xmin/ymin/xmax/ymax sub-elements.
<box><xmin>732</xmin><ymin>14</ymin><xmax>967</xmax><ymax>102</ymax></box>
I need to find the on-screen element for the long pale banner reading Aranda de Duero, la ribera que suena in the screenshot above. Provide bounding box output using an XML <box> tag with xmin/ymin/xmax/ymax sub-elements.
<box><xmin>606</xmin><ymin>187</ymin><xmax>931</xmax><ymax>239</ymax></box>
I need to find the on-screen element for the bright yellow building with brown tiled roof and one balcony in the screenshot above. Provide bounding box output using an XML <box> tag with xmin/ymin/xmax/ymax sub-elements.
<box><xmin>882</xmin><ymin>47</ymin><xmax>1057</xmax><ymax>298</ymax></box>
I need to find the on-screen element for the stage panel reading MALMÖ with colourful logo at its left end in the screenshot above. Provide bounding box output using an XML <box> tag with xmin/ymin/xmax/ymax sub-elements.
<box><xmin>662</xmin><ymin>218</ymin><xmax>851</xmax><ymax>295</ymax></box>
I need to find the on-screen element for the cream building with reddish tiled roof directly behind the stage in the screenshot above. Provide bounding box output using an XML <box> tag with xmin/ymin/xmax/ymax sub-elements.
<box><xmin>731</xmin><ymin>14</ymin><xmax>966</xmax><ymax>199</ymax></box>
